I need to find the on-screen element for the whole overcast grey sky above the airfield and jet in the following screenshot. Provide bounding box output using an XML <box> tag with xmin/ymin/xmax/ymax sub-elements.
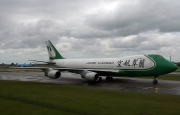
<box><xmin>0</xmin><ymin>0</ymin><xmax>180</xmax><ymax>63</ymax></box>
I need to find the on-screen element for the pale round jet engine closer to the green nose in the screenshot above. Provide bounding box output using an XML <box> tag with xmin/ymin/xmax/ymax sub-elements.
<box><xmin>84</xmin><ymin>72</ymin><xmax>99</xmax><ymax>81</ymax></box>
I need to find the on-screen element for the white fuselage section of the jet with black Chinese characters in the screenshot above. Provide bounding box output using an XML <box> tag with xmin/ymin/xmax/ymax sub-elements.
<box><xmin>53</xmin><ymin>55</ymin><xmax>155</xmax><ymax>70</ymax></box>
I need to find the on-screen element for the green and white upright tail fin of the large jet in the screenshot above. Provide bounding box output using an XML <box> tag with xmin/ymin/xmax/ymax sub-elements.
<box><xmin>45</xmin><ymin>41</ymin><xmax>64</xmax><ymax>60</ymax></box>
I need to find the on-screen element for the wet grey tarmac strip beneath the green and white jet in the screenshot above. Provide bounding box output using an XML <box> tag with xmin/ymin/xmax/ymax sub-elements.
<box><xmin>0</xmin><ymin>72</ymin><xmax>180</xmax><ymax>95</ymax></box>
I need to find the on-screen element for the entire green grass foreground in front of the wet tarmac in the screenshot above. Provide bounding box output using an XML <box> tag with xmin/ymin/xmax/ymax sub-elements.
<box><xmin>0</xmin><ymin>81</ymin><xmax>180</xmax><ymax>115</ymax></box>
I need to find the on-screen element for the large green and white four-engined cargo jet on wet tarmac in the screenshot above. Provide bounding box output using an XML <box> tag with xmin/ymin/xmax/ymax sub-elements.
<box><xmin>10</xmin><ymin>41</ymin><xmax>177</xmax><ymax>84</ymax></box>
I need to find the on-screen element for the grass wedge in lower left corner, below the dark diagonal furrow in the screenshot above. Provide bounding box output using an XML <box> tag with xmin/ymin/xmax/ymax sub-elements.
<box><xmin>0</xmin><ymin>97</ymin><xmax>72</xmax><ymax>115</ymax></box>
